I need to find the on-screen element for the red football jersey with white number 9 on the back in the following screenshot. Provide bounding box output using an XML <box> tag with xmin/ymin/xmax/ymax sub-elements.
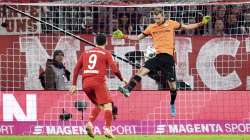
<box><xmin>73</xmin><ymin>47</ymin><xmax>122</xmax><ymax>85</ymax></box>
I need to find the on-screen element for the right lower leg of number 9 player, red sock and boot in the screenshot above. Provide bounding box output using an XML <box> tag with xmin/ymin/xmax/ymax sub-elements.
<box><xmin>103</xmin><ymin>103</ymin><xmax>114</xmax><ymax>138</ymax></box>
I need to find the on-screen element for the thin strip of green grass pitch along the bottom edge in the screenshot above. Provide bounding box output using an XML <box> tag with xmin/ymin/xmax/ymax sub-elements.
<box><xmin>0</xmin><ymin>135</ymin><xmax>250</xmax><ymax>140</ymax></box>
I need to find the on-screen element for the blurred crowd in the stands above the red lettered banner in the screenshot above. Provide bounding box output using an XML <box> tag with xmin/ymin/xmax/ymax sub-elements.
<box><xmin>41</xmin><ymin>4</ymin><xmax>250</xmax><ymax>36</ymax></box>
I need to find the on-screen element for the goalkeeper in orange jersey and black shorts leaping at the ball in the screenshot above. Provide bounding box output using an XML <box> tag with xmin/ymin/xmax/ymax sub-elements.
<box><xmin>112</xmin><ymin>8</ymin><xmax>211</xmax><ymax>117</ymax></box>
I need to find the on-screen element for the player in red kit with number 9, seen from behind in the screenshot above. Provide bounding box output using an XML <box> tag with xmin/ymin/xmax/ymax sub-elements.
<box><xmin>70</xmin><ymin>34</ymin><xmax>126</xmax><ymax>138</ymax></box>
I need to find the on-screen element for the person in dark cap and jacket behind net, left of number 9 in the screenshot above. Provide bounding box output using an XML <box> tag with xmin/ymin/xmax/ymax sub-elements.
<box><xmin>39</xmin><ymin>50</ymin><xmax>70</xmax><ymax>90</ymax></box>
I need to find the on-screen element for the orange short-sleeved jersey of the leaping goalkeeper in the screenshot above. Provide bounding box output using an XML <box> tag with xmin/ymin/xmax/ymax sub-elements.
<box><xmin>143</xmin><ymin>20</ymin><xmax>181</xmax><ymax>55</ymax></box>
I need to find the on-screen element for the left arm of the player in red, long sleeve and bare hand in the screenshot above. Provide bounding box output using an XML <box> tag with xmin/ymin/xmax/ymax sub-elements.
<box><xmin>70</xmin><ymin>55</ymin><xmax>83</xmax><ymax>94</ymax></box>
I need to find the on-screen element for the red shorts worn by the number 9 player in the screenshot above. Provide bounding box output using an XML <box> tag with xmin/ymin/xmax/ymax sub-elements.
<box><xmin>83</xmin><ymin>77</ymin><xmax>112</xmax><ymax>105</ymax></box>
